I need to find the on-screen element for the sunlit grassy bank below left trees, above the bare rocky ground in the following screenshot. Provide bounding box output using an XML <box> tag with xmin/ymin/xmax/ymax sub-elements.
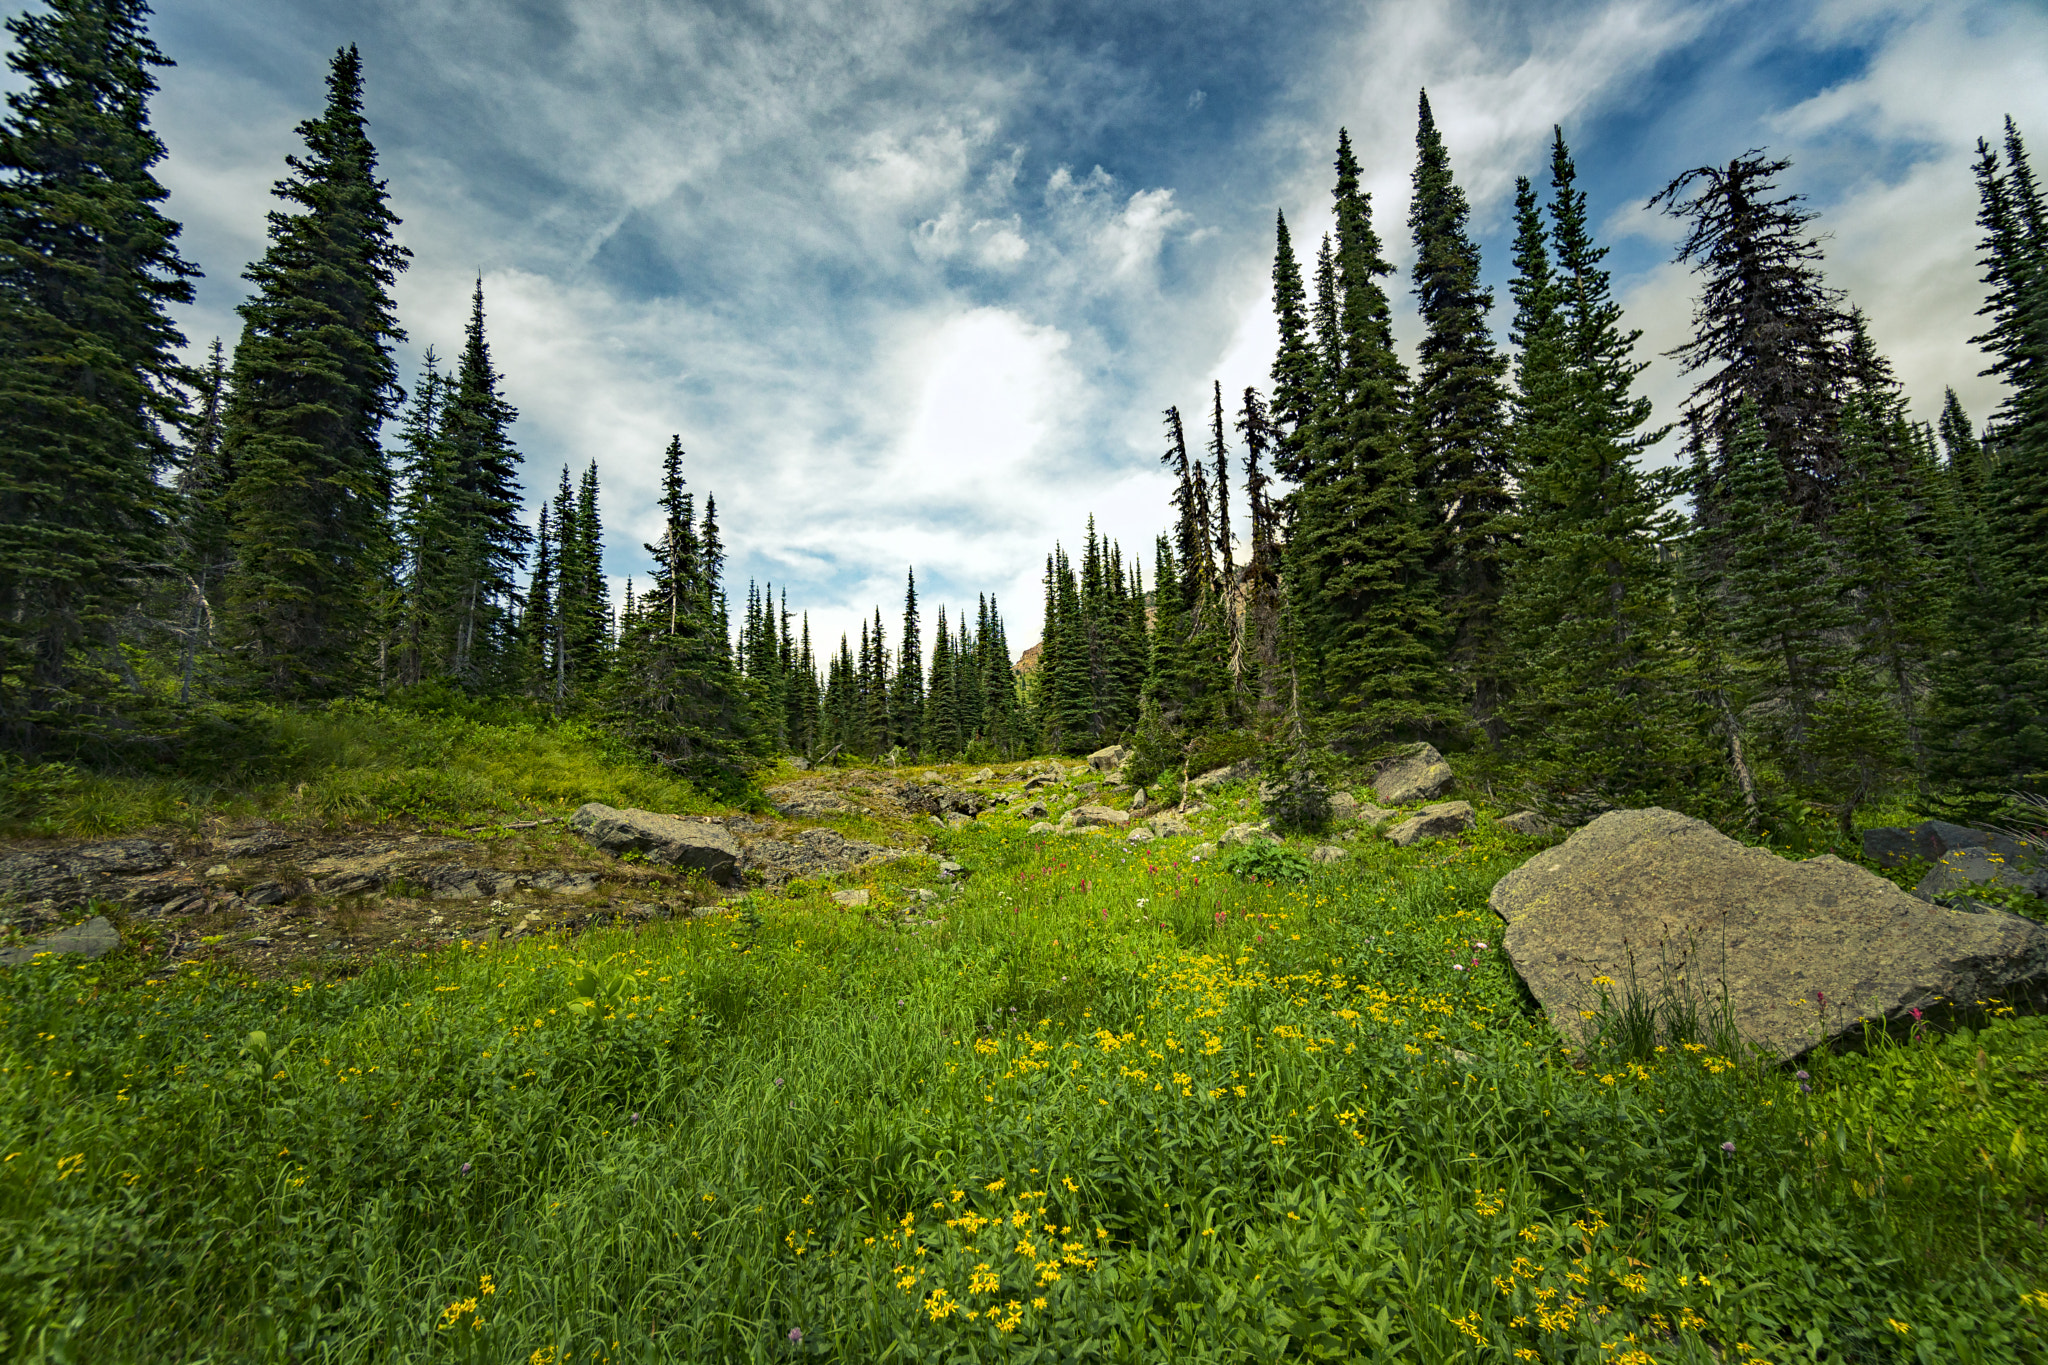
<box><xmin>0</xmin><ymin>698</ymin><xmax>733</xmax><ymax>839</ymax></box>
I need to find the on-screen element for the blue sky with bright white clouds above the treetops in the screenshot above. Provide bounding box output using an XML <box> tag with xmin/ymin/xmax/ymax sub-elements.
<box><xmin>68</xmin><ymin>0</ymin><xmax>2048</xmax><ymax>663</ymax></box>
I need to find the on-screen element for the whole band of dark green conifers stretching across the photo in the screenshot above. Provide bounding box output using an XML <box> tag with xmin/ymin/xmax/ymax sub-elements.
<box><xmin>0</xmin><ymin>0</ymin><xmax>2048</xmax><ymax>829</ymax></box>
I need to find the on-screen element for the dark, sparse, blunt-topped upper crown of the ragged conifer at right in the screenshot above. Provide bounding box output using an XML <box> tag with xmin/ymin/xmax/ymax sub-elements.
<box><xmin>1649</xmin><ymin>151</ymin><xmax>1847</xmax><ymax>524</ymax></box>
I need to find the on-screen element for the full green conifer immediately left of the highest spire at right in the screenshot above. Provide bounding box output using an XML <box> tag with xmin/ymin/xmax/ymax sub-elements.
<box><xmin>1288</xmin><ymin>131</ymin><xmax>1452</xmax><ymax>741</ymax></box>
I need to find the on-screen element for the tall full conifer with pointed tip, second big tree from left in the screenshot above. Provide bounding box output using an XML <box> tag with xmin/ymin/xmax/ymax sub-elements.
<box><xmin>225</xmin><ymin>47</ymin><xmax>410</xmax><ymax>698</ymax></box>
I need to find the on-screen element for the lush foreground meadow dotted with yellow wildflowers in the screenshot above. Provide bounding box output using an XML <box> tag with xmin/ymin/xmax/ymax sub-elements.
<box><xmin>0</xmin><ymin>785</ymin><xmax>2048</xmax><ymax>1365</ymax></box>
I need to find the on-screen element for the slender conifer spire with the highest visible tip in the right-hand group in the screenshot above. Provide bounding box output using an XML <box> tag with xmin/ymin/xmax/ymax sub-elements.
<box><xmin>1409</xmin><ymin>92</ymin><xmax>1511</xmax><ymax>722</ymax></box>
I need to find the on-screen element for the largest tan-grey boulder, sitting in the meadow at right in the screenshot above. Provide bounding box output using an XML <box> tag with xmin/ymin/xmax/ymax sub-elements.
<box><xmin>1489</xmin><ymin>808</ymin><xmax>2048</xmax><ymax>1058</ymax></box>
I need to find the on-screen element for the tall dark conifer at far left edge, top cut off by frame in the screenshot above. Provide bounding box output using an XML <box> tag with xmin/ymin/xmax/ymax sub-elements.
<box><xmin>0</xmin><ymin>0</ymin><xmax>199</xmax><ymax>751</ymax></box>
